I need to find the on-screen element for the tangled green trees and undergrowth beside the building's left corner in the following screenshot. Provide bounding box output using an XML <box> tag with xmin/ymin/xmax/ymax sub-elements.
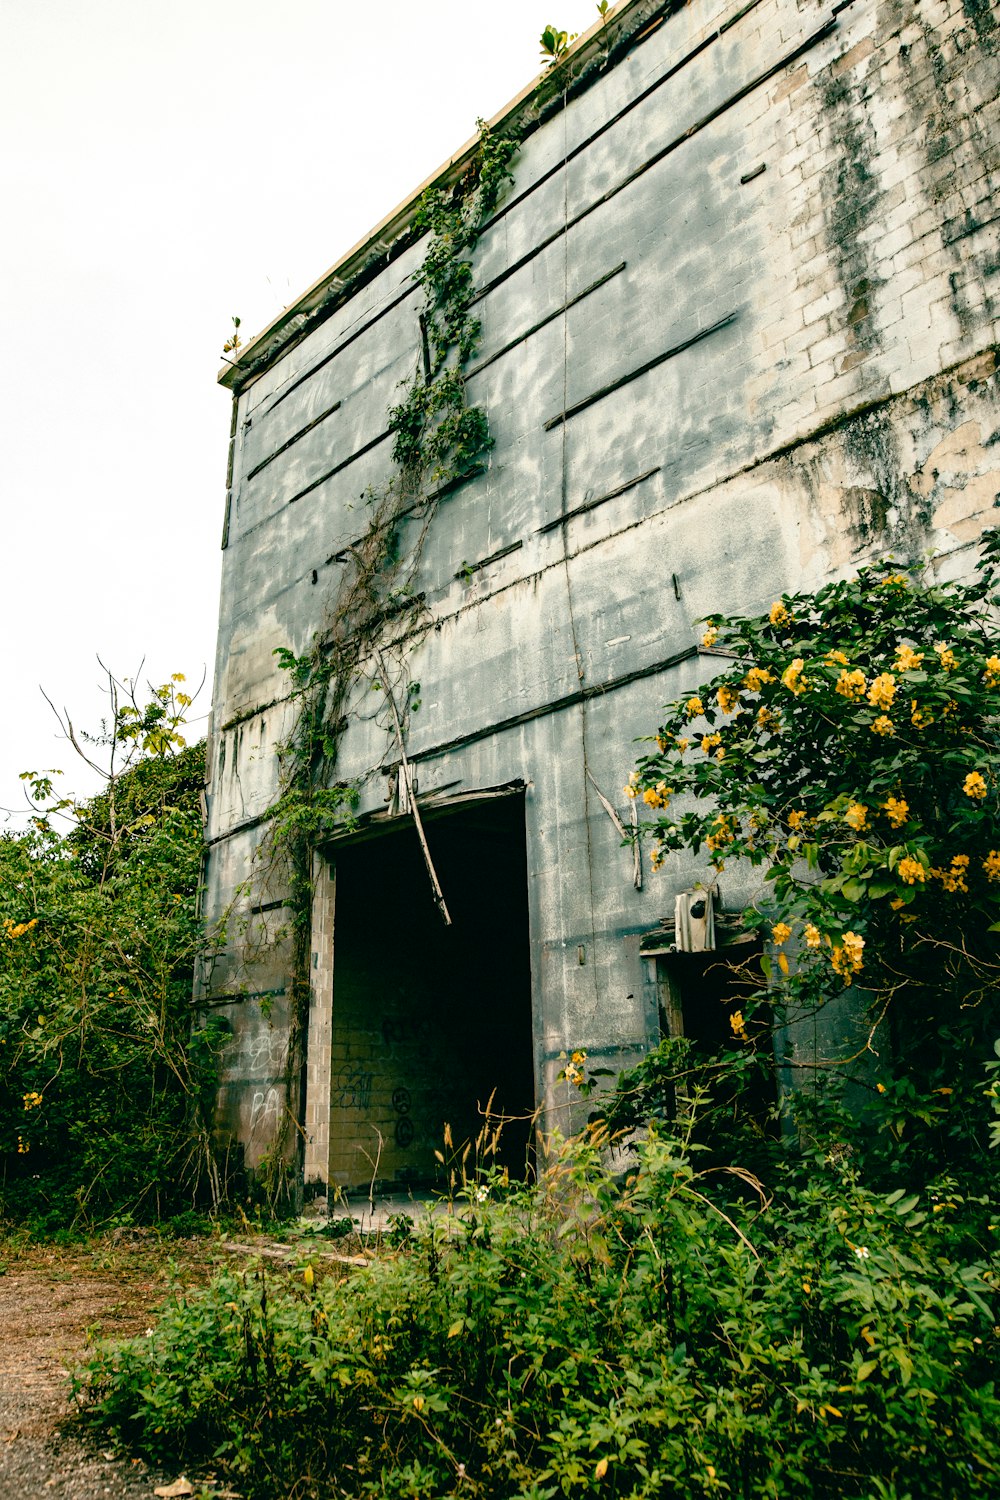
<box><xmin>0</xmin><ymin>675</ymin><xmax>223</xmax><ymax>1227</ymax></box>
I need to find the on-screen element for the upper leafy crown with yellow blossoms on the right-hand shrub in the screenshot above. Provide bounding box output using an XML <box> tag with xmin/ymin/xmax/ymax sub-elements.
<box><xmin>625</xmin><ymin>533</ymin><xmax>1000</xmax><ymax>984</ymax></box>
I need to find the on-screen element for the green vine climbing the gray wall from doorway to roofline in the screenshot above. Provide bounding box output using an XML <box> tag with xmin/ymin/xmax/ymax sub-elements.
<box><xmin>235</xmin><ymin>120</ymin><xmax>517</xmax><ymax>1194</ymax></box>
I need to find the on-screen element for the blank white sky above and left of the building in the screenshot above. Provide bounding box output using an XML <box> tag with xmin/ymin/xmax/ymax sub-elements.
<box><xmin>0</xmin><ymin>0</ymin><xmax>611</xmax><ymax>828</ymax></box>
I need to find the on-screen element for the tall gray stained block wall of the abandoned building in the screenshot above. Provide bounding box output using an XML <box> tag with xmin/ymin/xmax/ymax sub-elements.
<box><xmin>201</xmin><ymin>0</ymin><xmax>1000</xmax><ymax>1185</ymax></box>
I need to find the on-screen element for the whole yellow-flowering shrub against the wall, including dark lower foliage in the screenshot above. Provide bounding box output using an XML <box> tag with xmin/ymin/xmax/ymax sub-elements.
<box><xmin>625</xmin><ymin>531</ymin><xmax>1000</xmax><ymax>1166</ymax></box>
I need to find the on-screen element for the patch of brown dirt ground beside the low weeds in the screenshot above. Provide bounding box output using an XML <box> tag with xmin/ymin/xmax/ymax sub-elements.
<box><xmin>0</xmin><ymin>1238</ymin><xmax>226</xmax><ymax>1500</ymax></box>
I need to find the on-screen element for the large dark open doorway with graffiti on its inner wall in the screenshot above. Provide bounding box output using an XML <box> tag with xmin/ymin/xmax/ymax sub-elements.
<box><xmin>330</xmin><ymin>794</ymin><xmax>535</xmax><ymax>1191</ymax></box>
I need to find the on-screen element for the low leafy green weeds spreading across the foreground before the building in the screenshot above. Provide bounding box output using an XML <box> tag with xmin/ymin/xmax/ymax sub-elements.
<box><xmin>79</xmin><ymin>1128</ymin><xmax>1000</xmax><ymax>1500</ymax></box>
